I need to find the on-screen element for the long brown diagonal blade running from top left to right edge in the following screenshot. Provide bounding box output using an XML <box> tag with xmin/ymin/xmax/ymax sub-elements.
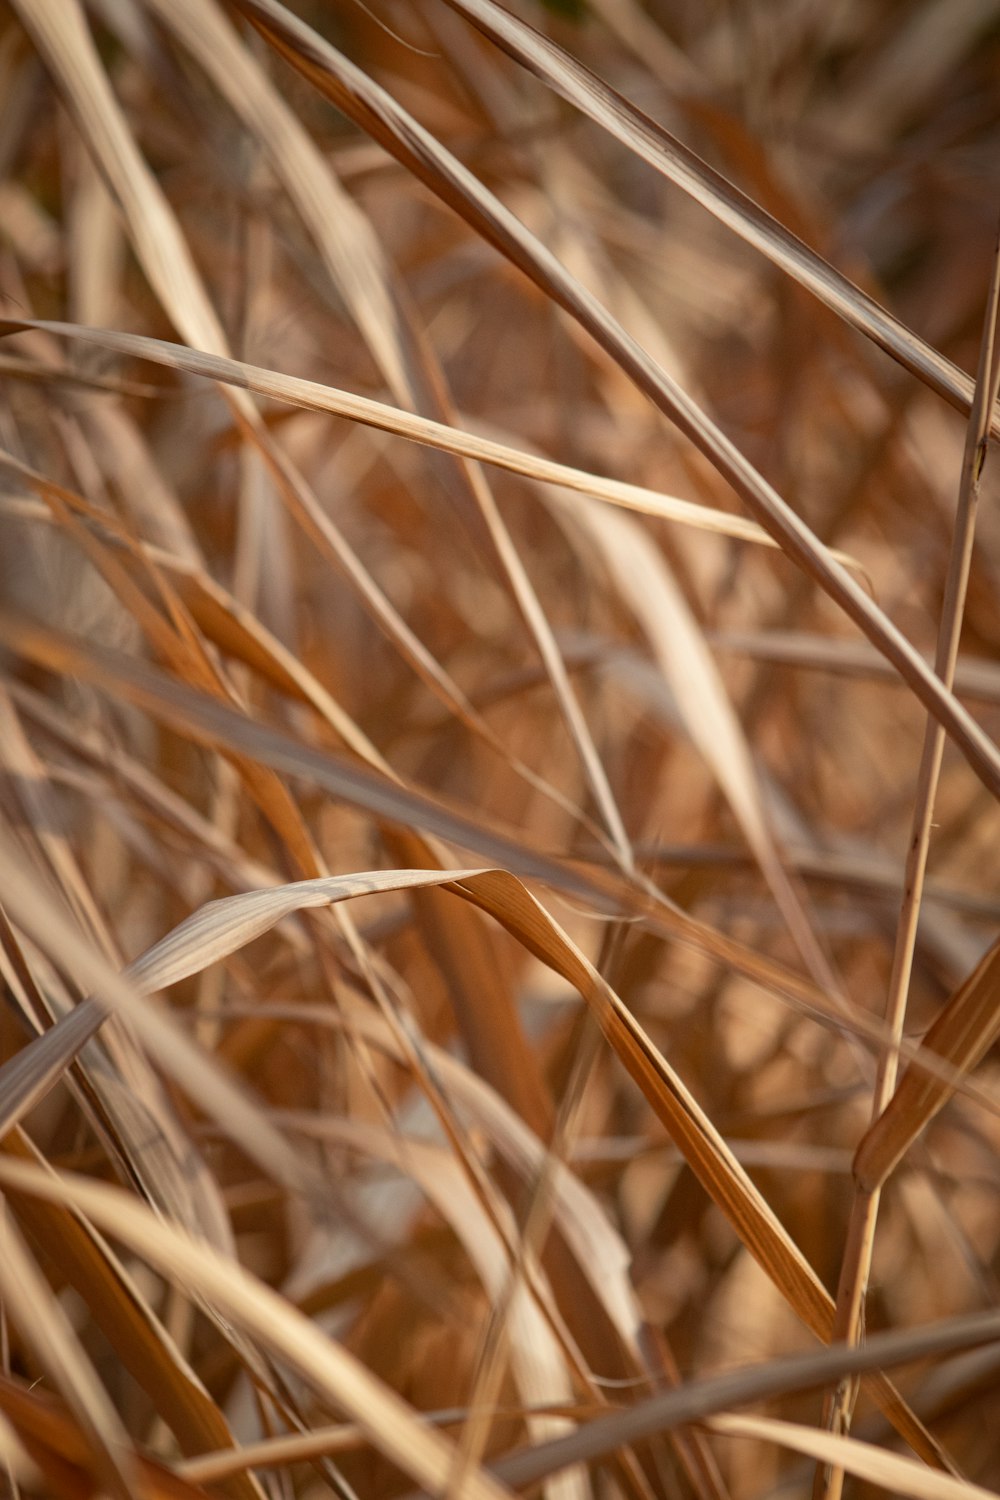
<box><xmin>193</xmin><ymin>0</ymin><xmax>1000</xmax><ymax>795</ymax></box>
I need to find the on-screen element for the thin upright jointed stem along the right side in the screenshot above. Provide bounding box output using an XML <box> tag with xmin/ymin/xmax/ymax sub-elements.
<box><xmin>813</xmin><ymin>222</ymin><xmax>1000</xmax><ymax>1500</ymax></box>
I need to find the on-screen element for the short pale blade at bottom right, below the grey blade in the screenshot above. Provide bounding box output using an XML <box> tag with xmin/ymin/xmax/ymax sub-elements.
<box><xmin>709</xmin><ymin>1416</ymin><xmax>996</xmax><ymax>1500</ymax></box>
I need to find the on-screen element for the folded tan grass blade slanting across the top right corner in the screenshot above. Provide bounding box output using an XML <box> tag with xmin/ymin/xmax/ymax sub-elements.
<box><xmin>445</xmin><ymin>0</ymin><xmax>1000</xmax><ymax>437</ymax></box>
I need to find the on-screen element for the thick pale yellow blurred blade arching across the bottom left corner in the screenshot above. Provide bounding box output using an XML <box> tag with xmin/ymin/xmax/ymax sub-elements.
<box><xmin>0</xmin><ymin>1158</ymin><xmax>508</xmax><ymax>1500</ymax></box>
